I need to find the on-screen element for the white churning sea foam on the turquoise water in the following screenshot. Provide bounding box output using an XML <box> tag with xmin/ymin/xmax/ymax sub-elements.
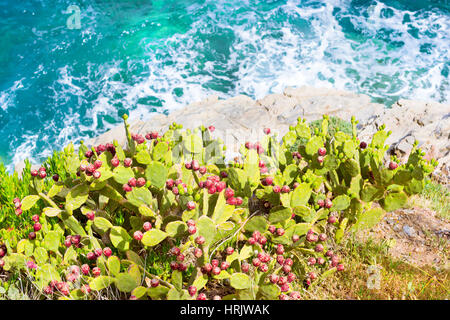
<box><xmin>7</xmin><ymin>0</ymin><xmax>450</xmax><ymax>171</ymax></box>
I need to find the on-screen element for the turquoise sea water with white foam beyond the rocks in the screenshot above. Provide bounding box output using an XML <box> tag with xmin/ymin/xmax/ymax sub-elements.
<box><xmin>0</xmin><ymin>0</ymin><xmax>450</xmax><ymax>167</ymax></box>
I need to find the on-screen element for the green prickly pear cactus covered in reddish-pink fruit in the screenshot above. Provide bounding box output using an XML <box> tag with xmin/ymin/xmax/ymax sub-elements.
<box><xmin>0</xmin><ymin>116</ymin><xmax>436</xmax><ymax>300</ymax></box>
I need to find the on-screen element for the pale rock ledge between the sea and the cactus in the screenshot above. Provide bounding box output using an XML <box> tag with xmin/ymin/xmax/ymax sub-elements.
<box><xmin>87</xmin><ymin>87</ymin><xmax>450</xmax><ymax>184</ymax></box>
